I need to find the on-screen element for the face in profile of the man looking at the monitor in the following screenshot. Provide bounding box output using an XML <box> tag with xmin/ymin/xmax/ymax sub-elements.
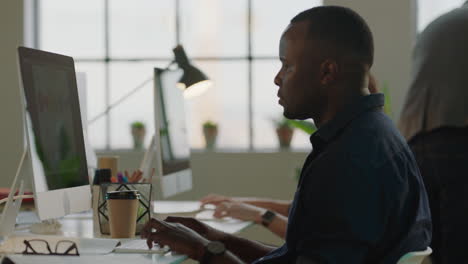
<box><xmin>274</xmin><ymin>21</ymin><xmax>325</xmax><ymax>119</ymax></box>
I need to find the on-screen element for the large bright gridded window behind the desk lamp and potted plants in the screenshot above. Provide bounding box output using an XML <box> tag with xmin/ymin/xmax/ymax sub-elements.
<box><xmin>36</xmin><ymin>0</ymin><xmax>321</xmax><ymax>150</ymax></box>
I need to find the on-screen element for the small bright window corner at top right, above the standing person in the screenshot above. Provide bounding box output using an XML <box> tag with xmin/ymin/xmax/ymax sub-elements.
<box><xmin>418</xmin><ymin>0</ymin><xmax>466</xmax><ymax>32</ymax></box>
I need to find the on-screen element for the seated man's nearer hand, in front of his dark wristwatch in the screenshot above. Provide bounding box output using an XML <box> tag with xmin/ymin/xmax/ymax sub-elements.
<box><xmin>141</xmin><ymin>218</ymin><xmax>209</xmax><ymax>261</ymax></box>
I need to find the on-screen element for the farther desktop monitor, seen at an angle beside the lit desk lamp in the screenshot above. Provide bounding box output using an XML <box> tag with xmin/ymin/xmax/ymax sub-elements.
<box><xmin>146</xmin><ymin>68</ymin><xmax>192</xmax><ymax>199</ymax></box>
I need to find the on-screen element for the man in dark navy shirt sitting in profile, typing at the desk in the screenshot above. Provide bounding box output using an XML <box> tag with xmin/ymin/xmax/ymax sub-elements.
<box><xmin>142</xmin><ymin>6</ymin><xmax>431</xmax><ymax>264</ymax></box>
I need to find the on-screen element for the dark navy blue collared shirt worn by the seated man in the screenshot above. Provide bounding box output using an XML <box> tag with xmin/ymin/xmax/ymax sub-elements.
<box><xmin>255</xmin><ymin>94</ymin><xmax>432</xmax><ymax>264</ymax></box>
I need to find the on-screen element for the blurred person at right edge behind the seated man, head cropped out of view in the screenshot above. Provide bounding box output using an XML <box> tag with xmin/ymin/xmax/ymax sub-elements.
<box><xmin>399</xmin><ymin>2</ymin><xmax>468</xmax><ymax>264</ymax></box>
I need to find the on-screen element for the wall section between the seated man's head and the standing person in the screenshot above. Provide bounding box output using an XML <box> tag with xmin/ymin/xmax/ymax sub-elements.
<box><xmin>324</xmin><ymin>0</ymin><xmax>417</xmax><ymax>121</ymax></box>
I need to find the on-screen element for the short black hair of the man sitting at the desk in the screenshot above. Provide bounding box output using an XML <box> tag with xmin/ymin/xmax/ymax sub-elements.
<box><xmin>291</xmin><ymin>6</ymin><xmax>374</xmax><ymax>67</ymax></box>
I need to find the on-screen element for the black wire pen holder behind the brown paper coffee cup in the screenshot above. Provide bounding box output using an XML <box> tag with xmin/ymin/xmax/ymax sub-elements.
<box><xmin>93</xmin><ymin>183</ymin><xmax>151</xmax><ymax>235</ymax></box>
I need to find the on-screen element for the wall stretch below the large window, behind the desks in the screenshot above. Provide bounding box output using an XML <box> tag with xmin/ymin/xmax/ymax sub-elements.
<box><xmin>98</xmin><ymin>151</ymin><xmax>307</xmax><ymax>200</ymax></box>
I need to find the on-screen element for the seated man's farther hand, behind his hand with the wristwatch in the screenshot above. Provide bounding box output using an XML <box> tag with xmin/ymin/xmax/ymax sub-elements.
<box><xmin>164</xmin><ymin>216</ymin><xmax>229</xmax><ymax>241</ymax></box>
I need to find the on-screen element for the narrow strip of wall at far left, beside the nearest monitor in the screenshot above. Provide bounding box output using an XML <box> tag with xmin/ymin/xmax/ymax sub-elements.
<box><xmin>0</xmin><ymin>0</ymin><xmax>23</xmax><ymax>190</ymax></box>
